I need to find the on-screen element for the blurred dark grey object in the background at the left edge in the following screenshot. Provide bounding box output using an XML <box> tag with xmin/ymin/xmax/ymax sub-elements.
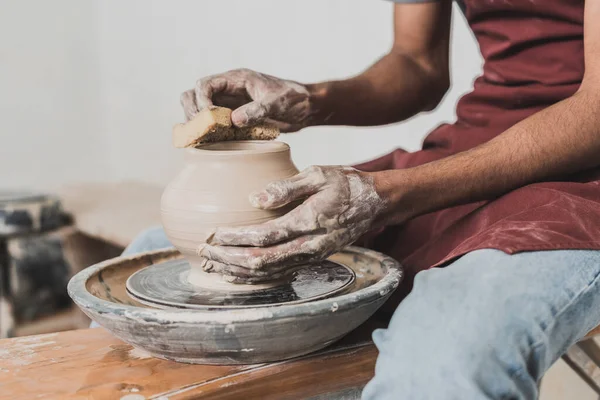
<box><xmin>0</xmin><ymin>191</ymin><xmax>74</xmax><ymax>337</ymax></box>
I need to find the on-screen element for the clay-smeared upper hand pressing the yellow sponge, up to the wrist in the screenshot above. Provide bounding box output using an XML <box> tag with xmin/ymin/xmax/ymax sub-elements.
<box><xmin>181</xmin><ymin>69</ymin><xmax>311</xmax><ymax>132</ymax></box>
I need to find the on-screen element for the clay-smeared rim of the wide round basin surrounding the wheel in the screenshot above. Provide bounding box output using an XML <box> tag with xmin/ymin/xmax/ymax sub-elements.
<box><xmin>67</xmin><ymin>246</ymin><xmax>404</xmax><ymax>326</ymax></box>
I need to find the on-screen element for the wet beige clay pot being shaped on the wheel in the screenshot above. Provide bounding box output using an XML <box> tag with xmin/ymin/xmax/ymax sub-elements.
<box><xmin>161</xmin><ymin>141</ymin><xmax>298</xmax><ymax>290</ymax></box>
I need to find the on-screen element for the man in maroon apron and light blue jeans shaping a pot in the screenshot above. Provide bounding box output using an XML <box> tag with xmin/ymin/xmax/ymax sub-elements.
<box><xmin>132</xmin><ymin>0</ymin><xmax>600</xmax><ymax>400</ymax></box>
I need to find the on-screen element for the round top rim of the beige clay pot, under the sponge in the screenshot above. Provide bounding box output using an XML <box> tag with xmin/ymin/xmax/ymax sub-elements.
<box><xmin>186</xmin><ymin>140</ymin><xmax>290</xmax><ymax>157</ymax></box>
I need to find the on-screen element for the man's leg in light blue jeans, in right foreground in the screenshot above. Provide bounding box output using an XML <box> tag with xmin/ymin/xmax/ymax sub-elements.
<box><xmin>362</xmin><ymin>250</ymin><xmax>600</xmax><ymax>400</ymax></box>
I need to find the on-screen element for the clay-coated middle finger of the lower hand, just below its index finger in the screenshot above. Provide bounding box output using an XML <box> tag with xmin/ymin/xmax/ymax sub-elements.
<box><xmin>199</xmin><ymin>235</ymin><xmax>328</xmax><ymax>270</ymax></box>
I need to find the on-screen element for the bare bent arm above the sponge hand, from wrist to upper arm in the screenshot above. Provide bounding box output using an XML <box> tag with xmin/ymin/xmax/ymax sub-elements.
<box><xmin>308</xmin><ymin>1</ymin><xmax>452</xmax><ymax>126</ymax></box>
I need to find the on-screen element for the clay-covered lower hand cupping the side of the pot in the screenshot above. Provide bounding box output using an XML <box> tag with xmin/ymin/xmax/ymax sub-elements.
<box><xmin>198</xmin><ymin>166</ymin><xmax>386</xmax><ymax>282</ymax></box>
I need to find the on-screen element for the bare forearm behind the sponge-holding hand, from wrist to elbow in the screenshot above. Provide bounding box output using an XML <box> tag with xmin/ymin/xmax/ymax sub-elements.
<box><xmin>308</xmin><ymin>52</ymin><xmax>449</xmax><ymax>126</ymax></box>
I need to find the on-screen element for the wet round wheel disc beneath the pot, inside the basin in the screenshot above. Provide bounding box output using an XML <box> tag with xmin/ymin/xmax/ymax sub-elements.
<box><xmin>126</xmin><ymin>259</ymin><xmax>355</xmax><ymax>309</ymax></box>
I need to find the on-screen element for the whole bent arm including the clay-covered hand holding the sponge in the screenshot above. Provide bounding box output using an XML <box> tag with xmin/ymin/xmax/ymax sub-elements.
<box><xmin>181</xmin><ymin>0</ymin><xmax>452</xmax><ymax>132</ymax></box>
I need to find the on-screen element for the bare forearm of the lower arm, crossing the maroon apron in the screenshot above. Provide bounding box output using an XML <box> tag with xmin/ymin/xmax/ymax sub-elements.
<box><xmin>374</xmin><ymin>90</ymin><xmax>600</xmax><ymax>223</ymax></box>
